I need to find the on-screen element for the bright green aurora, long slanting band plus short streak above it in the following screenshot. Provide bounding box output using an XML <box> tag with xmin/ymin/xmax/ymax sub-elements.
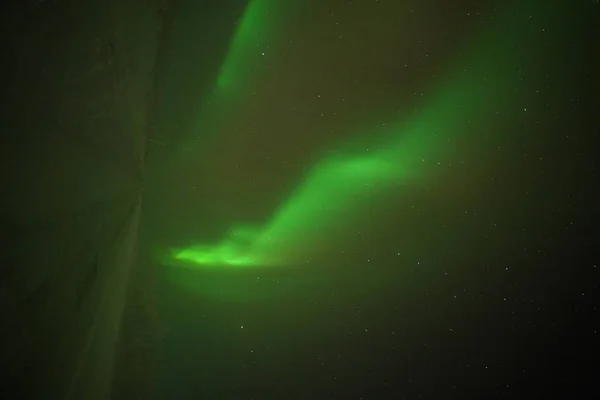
<box><xmin>172</xmin><ymin>0</ymin><xmax>559</xmax><ymax>268</ymax></box>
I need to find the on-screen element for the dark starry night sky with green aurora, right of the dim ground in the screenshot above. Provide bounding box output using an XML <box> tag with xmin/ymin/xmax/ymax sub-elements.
<box><xmin>140</xmin><ymin>0</ymin><xmax>600</xmax><ymax>399</ymax></box>
